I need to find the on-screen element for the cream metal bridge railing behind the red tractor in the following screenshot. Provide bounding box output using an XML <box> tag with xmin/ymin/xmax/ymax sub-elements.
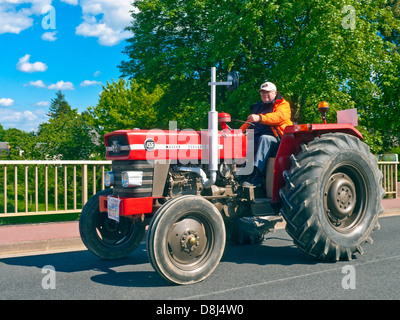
<box><xmin>0</xmin><ymin>160</ymin><xmax>399</xmax><ymax>217</ymax></box>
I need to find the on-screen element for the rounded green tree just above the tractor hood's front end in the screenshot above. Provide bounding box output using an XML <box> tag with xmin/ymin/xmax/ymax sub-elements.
<box><xmin>88</xmin><ymin>79</ymin><xmax>164</xmax><ymax>137</ymax></box>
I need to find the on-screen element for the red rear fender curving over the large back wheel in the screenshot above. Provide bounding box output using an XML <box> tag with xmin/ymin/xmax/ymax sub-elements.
<box><xmin>271</xmin><ymin>123</ymin><xmax>363</xmax><ymax>205</ymax></box>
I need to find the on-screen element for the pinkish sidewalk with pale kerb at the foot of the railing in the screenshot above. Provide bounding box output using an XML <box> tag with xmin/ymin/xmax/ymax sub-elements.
<box><xmin>0</xmin><ymin>198</ymin><xmax>400</xmax><ymax>258</ymax></box>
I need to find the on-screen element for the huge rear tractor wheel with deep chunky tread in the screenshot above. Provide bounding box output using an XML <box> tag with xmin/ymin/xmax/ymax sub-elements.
<box><xmin>280</xmin><ymin>133</ymin><xmax>384</xmax><ymax>261</ymax></box>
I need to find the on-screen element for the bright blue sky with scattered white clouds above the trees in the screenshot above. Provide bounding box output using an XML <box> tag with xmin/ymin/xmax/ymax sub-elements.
<box><xmin>0</xmin><ymin>0</ymin><xmax>133</xmax><ymax>132</ymax></box>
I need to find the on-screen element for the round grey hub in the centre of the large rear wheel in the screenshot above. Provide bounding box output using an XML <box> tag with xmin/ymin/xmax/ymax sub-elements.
<box><xmin>324</xmin><ymin>173</ymin><xmax>356</xmax><ymax>225</ymax></box>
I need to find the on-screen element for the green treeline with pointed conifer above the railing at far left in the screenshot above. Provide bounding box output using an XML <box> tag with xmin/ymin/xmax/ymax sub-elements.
<box><xmin>0</xmin><ymin>91</ymin><xmax>99</xmax><ymax>160</ymax></box>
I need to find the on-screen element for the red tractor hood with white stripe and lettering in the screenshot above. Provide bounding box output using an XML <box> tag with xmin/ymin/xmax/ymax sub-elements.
<box><xmin>104</xmin><ymin>129</ymin><xmax>247</xmax><ymax>164</ymax></box>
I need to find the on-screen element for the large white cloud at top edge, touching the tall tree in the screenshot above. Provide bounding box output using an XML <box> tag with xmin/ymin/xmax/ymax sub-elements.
<box><xmin>75</xmin><ymin>0</ymin><xmax>133</xmax><ymax>46</ymax></box>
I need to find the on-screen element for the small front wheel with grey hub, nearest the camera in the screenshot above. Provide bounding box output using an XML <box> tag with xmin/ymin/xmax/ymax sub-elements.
<box><xmin>147</xmin><ymin>195</ymin><xmax>226</xmax><ymax>284</ymax></box>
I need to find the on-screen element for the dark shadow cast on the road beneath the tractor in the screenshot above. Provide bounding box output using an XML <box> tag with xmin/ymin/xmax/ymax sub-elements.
<box><xmin>0</xmin><ymin>233</ymin><xmax>321</xmax><ymax>287</ymax></box>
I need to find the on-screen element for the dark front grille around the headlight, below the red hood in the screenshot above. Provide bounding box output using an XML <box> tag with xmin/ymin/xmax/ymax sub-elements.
<box><xmin>112</xmin><ymin>160</ymin><xmax>154</xmax><ymax>198</ymax></box>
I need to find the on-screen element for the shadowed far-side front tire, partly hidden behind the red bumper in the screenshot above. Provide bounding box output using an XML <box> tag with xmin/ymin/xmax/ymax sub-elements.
<box><xmin>79</xmin><ymin>189</ymin><xmax>146</xmax><ymax>259</ymax></box>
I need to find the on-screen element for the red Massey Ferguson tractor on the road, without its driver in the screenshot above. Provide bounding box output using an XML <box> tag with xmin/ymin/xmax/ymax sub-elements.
<box><xmin>79</xmin><ymin>68</ymin><xmax>384</xmax><ymax>284</ymax></box>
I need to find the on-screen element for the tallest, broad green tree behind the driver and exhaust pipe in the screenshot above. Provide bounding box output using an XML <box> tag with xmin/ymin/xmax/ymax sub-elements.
<box><xmin>119</xmin><ymin>0</ymin><xmax>400</xmax><ymax>151</ymax></box>
